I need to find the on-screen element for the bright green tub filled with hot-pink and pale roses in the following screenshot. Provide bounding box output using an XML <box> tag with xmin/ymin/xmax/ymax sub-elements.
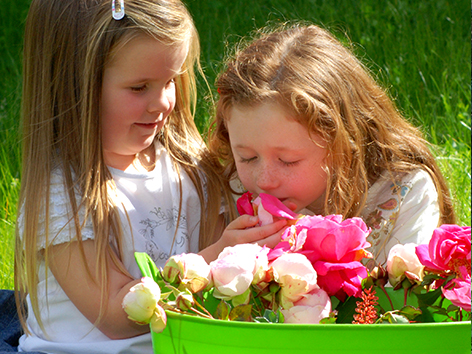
<box><xmin>123</xmin><ymin>194</ymin><xmax>471</xmax><ymax>353</ymax></box>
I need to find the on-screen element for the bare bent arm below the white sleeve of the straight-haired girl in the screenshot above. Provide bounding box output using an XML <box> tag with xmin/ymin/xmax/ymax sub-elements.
<box><xmin>48</xmin><ymin>240</ymin><xmax>149</xmax><ymax>339</ymax></box>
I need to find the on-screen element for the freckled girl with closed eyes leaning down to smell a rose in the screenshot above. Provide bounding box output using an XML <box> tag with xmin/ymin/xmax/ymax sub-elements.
<box><xmin>210</xmin><ymin>24</ymin><xmax>455</xmax><ymax>263</ymax></box>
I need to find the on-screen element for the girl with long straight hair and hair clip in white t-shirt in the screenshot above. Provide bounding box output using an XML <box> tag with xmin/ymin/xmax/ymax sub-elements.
<box><xmin>15</xmin><ymin>0</ymin><xmax>253</xmax><ymax>354</ymax></box>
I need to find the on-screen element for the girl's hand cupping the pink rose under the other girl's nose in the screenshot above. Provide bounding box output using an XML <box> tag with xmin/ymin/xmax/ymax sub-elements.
<box><xmin>199</xmin><ymin>215</ymin><xmax>287</xmax><ymax>263</ymax></box>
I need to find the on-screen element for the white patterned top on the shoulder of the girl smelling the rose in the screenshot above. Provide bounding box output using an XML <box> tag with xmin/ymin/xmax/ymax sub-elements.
<box><xmin>361</xmin><ymin>170</ymin><xmax>440</xmax><ymax>265</ymax></box>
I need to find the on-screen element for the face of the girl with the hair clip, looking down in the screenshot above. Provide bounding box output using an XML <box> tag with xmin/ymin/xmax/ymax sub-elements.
<box><xmin>100</xmin><ymin>35</ymin><xmax>188</xmax><ymax>170</ymax></box>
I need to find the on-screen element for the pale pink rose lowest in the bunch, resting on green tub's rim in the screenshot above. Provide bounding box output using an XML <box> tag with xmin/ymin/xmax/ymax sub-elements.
<box><xmin>281</xmin><ymin>289</ymin><xmax>331</xmax><ymax>324</ymax></box>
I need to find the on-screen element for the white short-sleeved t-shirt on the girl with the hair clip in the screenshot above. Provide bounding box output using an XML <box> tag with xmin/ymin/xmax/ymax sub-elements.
<box><xmin>18</xmin><ymin>147</ymin><xmax>201</xmax><ymax>354</ymax></box>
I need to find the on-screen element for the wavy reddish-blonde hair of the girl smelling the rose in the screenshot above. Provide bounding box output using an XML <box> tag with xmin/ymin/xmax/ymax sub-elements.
<box><xmin>210</xmin><ymin>24</ymin><xmax>455</xmax><ymax>223</ymax></box>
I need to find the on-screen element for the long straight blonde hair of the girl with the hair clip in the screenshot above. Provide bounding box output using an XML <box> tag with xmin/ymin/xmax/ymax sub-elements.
<box><xmin>15</xmin><ymin>0</ymin><xmax>236</xmax><ymax>332</ymax></box>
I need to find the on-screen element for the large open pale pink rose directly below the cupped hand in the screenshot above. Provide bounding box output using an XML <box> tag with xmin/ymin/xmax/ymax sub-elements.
<box><xmin>210</xmin><ymin>244</ymin><xmax>262</xmax><ymax>300</ymax></box>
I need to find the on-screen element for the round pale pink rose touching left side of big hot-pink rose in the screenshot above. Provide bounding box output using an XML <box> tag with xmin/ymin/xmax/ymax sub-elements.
<box><xmin>270</xmin><ymin>253</ymin><xmax>318</xmax><ymax>308</ymax></box>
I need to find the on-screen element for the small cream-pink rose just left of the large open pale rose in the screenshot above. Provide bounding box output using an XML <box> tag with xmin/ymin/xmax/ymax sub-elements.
<box><xmin>162</xmin><ymin>253</ymin><xmax>211</xmax><ymax>293</ymax></box>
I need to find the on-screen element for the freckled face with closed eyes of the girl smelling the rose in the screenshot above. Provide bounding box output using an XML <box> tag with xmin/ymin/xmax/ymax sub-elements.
<box><xmin>227</xmin><ymin>102</ymin><xmax>327</xmax><ymax>211</ymax></box>
